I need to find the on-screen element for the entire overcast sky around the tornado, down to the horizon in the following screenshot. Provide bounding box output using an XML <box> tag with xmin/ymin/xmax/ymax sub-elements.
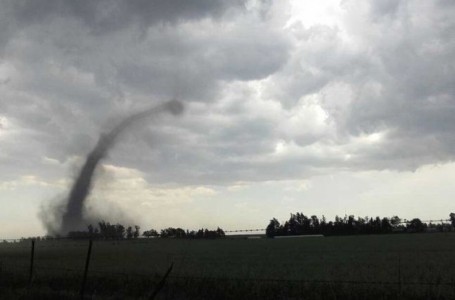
<box><xmin>0</xmin><ymin>0</ymin><xmax>455</xmax><ymax>238</ymax></box>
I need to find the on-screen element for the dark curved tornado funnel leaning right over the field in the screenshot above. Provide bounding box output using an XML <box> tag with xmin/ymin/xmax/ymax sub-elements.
<box><xmin>58</xmin><ymin>100</ymin><xmax>183</xmax><ymax>235</ymax></box>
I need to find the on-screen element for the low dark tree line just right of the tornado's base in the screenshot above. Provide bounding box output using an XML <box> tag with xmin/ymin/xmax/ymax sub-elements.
<box><xmin>67</xmin><ymin>221</ymin><xmax>225</xmax><ymax>240</ymax></box>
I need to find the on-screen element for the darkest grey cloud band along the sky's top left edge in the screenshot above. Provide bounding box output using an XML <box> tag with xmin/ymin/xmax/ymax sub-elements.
<box><xmin>6</xmin><ymin>0</ymin><xmax>245</xmax><ymax>35</ymax></box>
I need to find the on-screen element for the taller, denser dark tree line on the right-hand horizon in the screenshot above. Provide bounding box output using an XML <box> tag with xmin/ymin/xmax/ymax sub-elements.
<box><xmin>266</xmin><ymin>212</ymin><xmax>455</xmax><ymax>237</ymax></box>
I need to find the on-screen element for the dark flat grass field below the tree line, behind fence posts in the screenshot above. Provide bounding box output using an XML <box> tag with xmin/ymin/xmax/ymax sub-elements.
<box><xmin>0</xmin><ymin>233</ymin><xmax>455</xmax><ymax>299</ymax></box>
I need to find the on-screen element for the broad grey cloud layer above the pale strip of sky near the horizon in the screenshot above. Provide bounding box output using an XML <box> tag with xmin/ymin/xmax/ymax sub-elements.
<box><xmin>0</xmin><ymin>0</ymin><xmax>455</xmax><ymax>188</ymax></box>
